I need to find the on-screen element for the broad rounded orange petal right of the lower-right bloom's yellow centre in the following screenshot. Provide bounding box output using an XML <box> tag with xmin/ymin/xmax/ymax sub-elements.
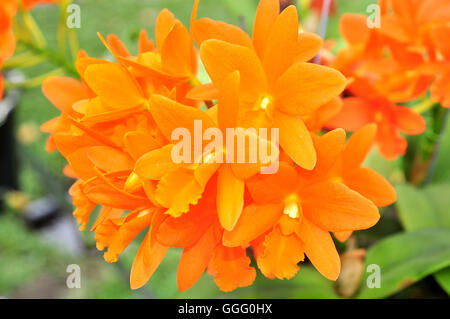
<box><xmin>301</xmin><ymin>182</ymin><xmax>380</xmax><ymax>232</ymax></box>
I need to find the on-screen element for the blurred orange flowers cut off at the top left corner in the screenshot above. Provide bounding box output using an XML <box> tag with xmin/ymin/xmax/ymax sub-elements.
<box><xmin>0</xmin><ymin>0</ymin><xmax>60</xmax><ymax>101</ymax></box>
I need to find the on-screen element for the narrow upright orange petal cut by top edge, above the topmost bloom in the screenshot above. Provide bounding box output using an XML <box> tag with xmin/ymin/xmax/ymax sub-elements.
<box><xmin>253</xmin><ymin>0</ymin><xmax>280</xmax><ymax>57</ymax></box>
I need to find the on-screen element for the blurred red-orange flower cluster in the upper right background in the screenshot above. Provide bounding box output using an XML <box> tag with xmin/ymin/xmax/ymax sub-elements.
<box><xmin>328</xmin><ymin>0</ymin><xmax>450</xmax><ymax>159</ymax></box>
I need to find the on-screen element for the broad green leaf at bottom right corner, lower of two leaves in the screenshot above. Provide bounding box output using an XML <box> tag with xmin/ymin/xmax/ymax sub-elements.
<box><xmin>358</xmin><ymin>229</ymin><xmax>450</xmax><ymax>299</ymax></box>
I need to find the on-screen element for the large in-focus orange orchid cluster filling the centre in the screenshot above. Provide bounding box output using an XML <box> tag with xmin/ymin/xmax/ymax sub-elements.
<box><xmin>42</xmin><ymin>0</ymin><xmax>396</xmax><ymax>291</ymax></box>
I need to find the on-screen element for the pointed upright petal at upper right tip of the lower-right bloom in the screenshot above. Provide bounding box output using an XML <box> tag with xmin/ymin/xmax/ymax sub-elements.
<box><xmin>343</xmin><ymin>124</ymin><xmax>377</xmax><ymax>172</ymax></box>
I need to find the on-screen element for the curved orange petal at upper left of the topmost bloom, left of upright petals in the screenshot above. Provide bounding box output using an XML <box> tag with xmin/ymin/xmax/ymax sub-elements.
<box><xmin>193</xmin><ymin>18</ymin><xmax>253</xmax><ymax>48</ymax></box>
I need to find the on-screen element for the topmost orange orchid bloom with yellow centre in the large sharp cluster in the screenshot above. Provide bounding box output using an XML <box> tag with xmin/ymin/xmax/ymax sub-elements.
<box><xmin>193</xmin><ymin>0</ymin><xmax>346</xmax><ymax>169</ymax></box>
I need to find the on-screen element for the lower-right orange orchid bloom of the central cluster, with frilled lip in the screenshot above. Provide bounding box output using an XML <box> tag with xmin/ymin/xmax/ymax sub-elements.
<box><xmin>224</xmin><ymin>125</ymin><xmax>395</xmax><ymax>280</ymax></box>
